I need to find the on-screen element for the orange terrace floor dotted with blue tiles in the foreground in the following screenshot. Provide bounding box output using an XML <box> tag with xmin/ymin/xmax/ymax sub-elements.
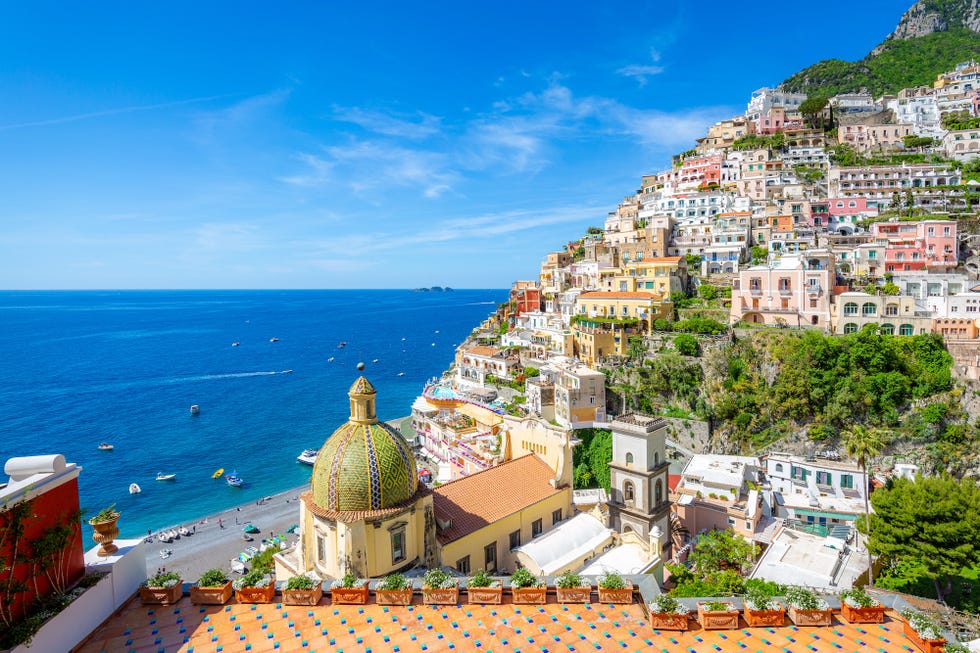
<box><xmin>74</xmin><ymin>597</ymin><xmax>918</xmax><ymax>653</ymax></box>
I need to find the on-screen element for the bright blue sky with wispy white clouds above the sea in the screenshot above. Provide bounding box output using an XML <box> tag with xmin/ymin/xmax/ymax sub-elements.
<box><xmin>0</xmin><ymin>0</ymin><xmax>908</xmax><ymax>289</ymax></box>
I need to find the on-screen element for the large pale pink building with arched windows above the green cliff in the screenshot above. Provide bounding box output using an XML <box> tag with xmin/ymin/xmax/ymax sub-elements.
<box><xmin>730</xmin><ymin>249</ymin><xmax>836</xmax><ymax>329</ymax></box>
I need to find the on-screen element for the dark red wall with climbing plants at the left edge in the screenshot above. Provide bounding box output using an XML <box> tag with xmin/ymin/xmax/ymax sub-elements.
<box><xmin>0</xmin><ymin>478</ymin><xmax>85</xmax><ymax>619</ymax></box>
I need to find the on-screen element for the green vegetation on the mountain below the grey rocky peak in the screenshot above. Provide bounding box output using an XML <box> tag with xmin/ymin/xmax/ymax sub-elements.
<box><xmin>782</xmin><ymin>28</ymin><xmax>980</xmax><ymax>97</ymax></box>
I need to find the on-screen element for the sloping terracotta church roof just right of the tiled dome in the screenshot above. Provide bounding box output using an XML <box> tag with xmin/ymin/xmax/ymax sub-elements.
<box><xmin>432</xmin><ymin>453</ymin><xmax>563</xmax><ymax>544</ymax></box>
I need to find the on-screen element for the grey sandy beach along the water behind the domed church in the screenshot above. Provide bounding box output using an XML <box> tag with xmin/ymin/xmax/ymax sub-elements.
<box><xmin>143</xmin><ymin>415</ymin><xmax>411</xmax><ymax>583</ymax></box>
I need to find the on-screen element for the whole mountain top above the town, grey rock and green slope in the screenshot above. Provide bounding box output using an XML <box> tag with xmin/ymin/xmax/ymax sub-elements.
<box><xmin>782</xmin><ymin>0</ymin><xmax>980</xmax><ymax>96</ymax></box>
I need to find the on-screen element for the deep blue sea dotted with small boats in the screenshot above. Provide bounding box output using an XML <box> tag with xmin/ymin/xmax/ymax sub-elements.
<box><xmin>0</xmin><ymin>290</ymin><xmax>507</xmax><ymax>537</ymax></box>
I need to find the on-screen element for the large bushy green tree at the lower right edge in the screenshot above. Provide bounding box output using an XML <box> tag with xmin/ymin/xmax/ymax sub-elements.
<box><xmin>869</xmin><ymin>476</ymin><xmax>980</xmax><ymax>599</ymax></box>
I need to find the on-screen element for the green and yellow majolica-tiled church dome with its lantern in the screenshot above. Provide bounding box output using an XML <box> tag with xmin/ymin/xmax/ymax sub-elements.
<box><xmin>312</xmin><ymin>376</ymin><xmax>419</xmax><ymax>512</ymax></box>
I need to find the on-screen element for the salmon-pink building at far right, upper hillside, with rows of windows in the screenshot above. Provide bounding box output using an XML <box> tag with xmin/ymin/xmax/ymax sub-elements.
<box><xmin>871</xmin><ymin>220</ymin><xmax>958</xmax><ymax>273</ymax></box>
